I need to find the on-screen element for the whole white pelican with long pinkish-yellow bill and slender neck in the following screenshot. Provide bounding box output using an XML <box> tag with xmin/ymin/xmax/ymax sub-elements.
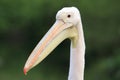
<box><xmin>23</xmin><ymin>7</ymin><xmax>85</xmax><ymax>80</ymax></box>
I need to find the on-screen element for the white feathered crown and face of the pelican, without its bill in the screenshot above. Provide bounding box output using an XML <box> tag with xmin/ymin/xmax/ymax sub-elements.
<box><xmin>56</xmin><ymin>7</ymin><xmax>80</xmax><ymax>26</ymax></box>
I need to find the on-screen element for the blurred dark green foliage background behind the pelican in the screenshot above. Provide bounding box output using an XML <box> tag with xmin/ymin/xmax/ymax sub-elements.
<box><xmin>0</xmin><ymin>0</ymin><xmax>120</xmax><ymax>80</ymax></box>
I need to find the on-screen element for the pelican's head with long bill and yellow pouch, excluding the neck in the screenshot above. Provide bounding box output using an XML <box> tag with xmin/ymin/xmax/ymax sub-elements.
<box><xmin>24</xmin><ymin>7</ymin><xmax>81</xmax><ymax>74</ymax></box>
